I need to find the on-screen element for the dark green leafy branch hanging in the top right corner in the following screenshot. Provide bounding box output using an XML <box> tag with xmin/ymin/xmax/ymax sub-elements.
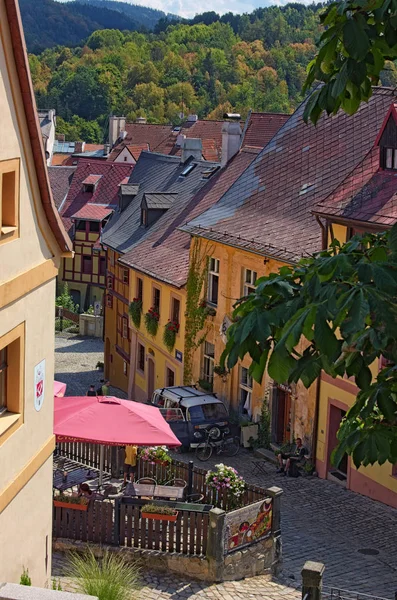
<box><xmin>304</xmin><ymin>0</ymin><xmax>397</xmax><ymax>123</ymax></box>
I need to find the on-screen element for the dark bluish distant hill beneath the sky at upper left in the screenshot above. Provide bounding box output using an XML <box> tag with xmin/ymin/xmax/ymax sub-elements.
<box><xmin>19</xmin><ymin>0</ymin><xmax>170</xmax><ymax>53</ymax></box>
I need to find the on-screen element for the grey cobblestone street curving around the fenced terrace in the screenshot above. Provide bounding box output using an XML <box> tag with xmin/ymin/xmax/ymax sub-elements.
<box><xmin>54</xmin><ymin>335</ymin><xmax>397</xmax><ymax>600</ymax></box>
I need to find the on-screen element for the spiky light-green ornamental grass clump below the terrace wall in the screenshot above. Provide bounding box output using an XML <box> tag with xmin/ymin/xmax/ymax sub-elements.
<box><xmin>67</xmin><ymin>548</ymin><xmax>140</xmax><ymax>600</ymax></box>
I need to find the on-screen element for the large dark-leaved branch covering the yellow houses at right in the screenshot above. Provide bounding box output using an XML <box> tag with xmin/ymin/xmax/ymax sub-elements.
<box><xmin>222</xmin><ymin>225</ymin><xmax>397</xmax><ymax>467</ymax></box>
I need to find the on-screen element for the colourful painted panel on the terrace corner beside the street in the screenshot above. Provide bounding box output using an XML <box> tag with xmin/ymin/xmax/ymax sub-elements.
<box><xmin>225</xmin><ymin>498</ymin><xmax>272</xmax><ymax>552</ymax></box>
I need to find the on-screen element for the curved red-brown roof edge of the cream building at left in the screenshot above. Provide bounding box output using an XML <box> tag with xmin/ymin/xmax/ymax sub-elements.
<box><xmin>4</xmin><ymin>0</ymin><xmax>73</xmax><ymax>253</ymax></box>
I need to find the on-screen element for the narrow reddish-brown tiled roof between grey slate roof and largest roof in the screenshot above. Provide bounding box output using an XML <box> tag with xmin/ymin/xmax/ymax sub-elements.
<box><xmin>120</xmin><ymin>149</ymin><xmax>258</xmax><ymax>288</ymax></box>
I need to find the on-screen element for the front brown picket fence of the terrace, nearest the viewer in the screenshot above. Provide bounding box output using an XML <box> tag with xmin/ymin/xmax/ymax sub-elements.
<box><xmin>53</xmin><ymin>501</ymin><xmax>209</xmax><ymax>556</ymax></box>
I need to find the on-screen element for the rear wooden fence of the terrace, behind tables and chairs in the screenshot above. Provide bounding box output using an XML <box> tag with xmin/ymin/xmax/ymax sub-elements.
<box><xmin>58</xmin><ymin>442</ymin><xmax>265</xmax><ymax>510</ymax></box>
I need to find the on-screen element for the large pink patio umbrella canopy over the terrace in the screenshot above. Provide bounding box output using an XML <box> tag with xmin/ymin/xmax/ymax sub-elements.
<box><xmin>54</xmin><ymin>396</ymin><xmax>181</xmax><ymax>446</ymax></box>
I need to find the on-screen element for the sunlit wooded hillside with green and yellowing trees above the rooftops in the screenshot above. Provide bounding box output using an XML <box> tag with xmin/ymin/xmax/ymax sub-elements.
<box><xmin>30</xmin><ymin>4</ymin><xmax>397</xmax><ymax>141</ymax></box>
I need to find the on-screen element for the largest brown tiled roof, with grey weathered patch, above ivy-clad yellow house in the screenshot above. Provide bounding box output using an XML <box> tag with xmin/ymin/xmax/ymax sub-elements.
<box><xmin>183</xmin><ymin>87</ymin><xmax>394</xmax><ymax>262</ymax></box>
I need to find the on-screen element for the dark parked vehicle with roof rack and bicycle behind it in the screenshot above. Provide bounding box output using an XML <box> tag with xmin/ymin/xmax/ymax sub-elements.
<box><xmin>151</xmin><ymin>386</ymin><xmax>229</xmax><ymax>448</ymax></box>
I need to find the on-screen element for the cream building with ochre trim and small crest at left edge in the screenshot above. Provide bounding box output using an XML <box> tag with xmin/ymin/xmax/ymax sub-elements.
<box><xmin>0</xmin><ymin>0</ymin><xmax>71</xmax><ymax>586</ymax></box>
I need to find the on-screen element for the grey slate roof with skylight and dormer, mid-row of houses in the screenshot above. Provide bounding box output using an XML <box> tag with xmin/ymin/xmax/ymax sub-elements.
<box><xmin>102</xmin><ymin>152</ymin><xmax>220</xmax><ymax>254</ymax></box>
